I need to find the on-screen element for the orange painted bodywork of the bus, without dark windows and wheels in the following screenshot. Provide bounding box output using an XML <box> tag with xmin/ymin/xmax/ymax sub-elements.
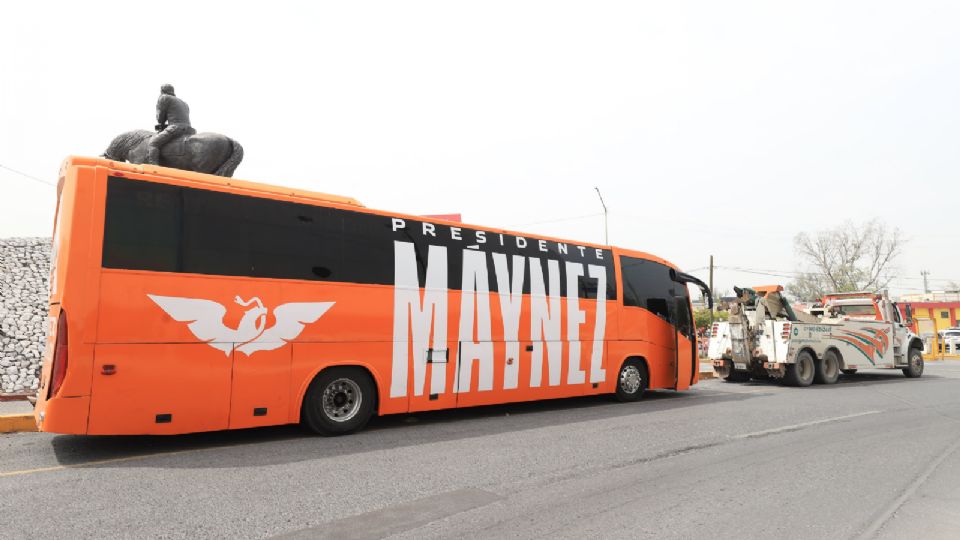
<box><xmin>36</xmin><ymin>158</ymin><xmax>697</xmax><ymax>434</ymax></box>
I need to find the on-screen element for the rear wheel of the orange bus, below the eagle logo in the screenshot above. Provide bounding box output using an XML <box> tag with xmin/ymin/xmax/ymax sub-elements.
<box><xmin>300</xmin><ymin>366</ymin><xmax>376</xmax><ymax>435</ymax></box>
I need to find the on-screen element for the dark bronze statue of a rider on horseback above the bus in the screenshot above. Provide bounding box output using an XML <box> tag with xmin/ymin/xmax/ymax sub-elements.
<box><xmin>103</xmin><ymin>84</ymin><xmax>243</xmax><ymax>177</ymax></box>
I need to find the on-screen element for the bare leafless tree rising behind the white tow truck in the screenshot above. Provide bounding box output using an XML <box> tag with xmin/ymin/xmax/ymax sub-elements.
<box><xmin>787</xmin><ymin>219</ymin><xmax>904</xmax><ymax>301</ymax></box>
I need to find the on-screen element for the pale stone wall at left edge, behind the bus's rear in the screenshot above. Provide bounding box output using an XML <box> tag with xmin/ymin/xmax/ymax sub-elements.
<box><xmin>0</xmin><ymin>238</ymin><xmax>50</xmax><ymax>394</ymax></box>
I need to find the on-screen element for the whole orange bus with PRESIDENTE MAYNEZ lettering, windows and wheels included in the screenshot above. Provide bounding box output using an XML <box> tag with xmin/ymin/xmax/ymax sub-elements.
<box><xmin>35</xmin><ymin>157</ymin><xmax>709</xmax><ymax>434</ymax></box>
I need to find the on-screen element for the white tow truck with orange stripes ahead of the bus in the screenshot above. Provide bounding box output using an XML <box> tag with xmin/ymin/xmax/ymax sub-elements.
<box><xmin>709</xmin><ymin>286</ymin><xmax>923</xmax><ymax>386</ymax></box>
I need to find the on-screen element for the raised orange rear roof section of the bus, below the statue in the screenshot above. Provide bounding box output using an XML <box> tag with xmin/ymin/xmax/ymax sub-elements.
<box><xmin>60</xmin><ymin>156</ymin><xmax>363</xmax><ymax>207</ymax></box>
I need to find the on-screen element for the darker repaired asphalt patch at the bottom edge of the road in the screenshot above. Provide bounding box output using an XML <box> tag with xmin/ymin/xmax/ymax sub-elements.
<box><xmin>274</xmin><ymin>488</ymin><xmax>503</xmax><ymax>540</ymax></box>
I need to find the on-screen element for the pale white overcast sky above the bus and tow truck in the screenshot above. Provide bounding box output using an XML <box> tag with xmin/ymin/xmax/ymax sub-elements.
<box><xmin>0</xmin><ymin>0</ymin><xmax>960</xmax><ymax>298</ymax></box>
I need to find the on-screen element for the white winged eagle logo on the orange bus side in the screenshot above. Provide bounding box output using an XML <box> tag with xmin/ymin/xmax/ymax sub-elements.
<box><xmin>147</xmin><ymin>294</ymin><xmax>334</xmax><ymax>356</ymax></box>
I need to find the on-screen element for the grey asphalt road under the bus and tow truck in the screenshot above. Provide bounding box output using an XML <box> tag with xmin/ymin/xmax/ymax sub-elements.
<box><xmin>0</xmin><ymin>363</ymin><xmax>960</xmax><ymax>539</ymax></box>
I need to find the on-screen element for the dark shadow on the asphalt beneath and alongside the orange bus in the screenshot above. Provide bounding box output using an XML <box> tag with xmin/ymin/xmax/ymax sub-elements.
<box><xmin>52</xmin><ymin>391</ymin><xmax>766</xmax><ymax>468</ymax></box>
